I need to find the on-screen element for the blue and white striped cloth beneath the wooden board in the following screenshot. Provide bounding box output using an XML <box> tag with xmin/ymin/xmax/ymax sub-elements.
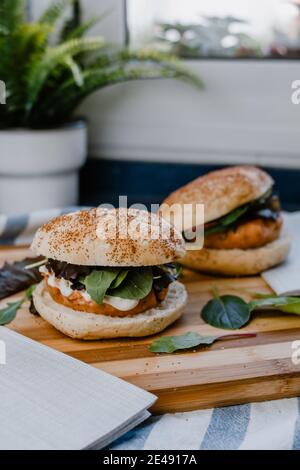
<box><xmin>0</xmin><ymin>207</ymin><xmax>300</xmax><ymax>450</ymax></box>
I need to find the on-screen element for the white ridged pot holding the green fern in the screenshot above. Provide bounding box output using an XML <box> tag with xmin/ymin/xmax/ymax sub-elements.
<box><xmin>0</xmin><ymin>121</ymin><xmax>87</xmax><ymax>214</ymax></box>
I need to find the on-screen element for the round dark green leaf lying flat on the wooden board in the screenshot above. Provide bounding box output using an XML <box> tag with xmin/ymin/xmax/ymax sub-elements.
<box><xmin>202</xmin><ymin>295</ymin><xmax>253</xmax><ymax>330</ymax></box>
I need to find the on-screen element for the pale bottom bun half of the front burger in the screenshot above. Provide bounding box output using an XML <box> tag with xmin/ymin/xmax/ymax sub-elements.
<box><xmin>33</xmin><ymin>281</ymin><xmax>187</xmax><ymax>340</ymax></box>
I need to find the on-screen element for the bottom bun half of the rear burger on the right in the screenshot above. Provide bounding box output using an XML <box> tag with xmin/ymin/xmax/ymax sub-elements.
<box><xmin>180</xmin><ymin>233</ymin><xmax>291</xmax><ymax>276</ymax></box>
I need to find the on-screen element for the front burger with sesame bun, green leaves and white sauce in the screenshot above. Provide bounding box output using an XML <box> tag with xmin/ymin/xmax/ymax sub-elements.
<box><xmin>31</xmin><ymin>208</ymin><xmax>187</xmax><ymax>340</ymax></box>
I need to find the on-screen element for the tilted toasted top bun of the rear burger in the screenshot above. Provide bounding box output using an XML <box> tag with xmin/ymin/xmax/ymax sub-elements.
<box><xmin>161</xmin><ymin>166</ymin><xmax>274</xmax><ymax>227</ymax></box>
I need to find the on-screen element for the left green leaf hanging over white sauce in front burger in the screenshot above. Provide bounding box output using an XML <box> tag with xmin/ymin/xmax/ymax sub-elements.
<box><xmin>82</xmin><ymin>268</ymin><xmax>120</xmax><ymax>305</ymax></box>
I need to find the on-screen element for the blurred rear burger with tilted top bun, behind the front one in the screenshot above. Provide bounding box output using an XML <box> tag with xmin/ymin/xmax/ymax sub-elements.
<box><xmin>161</xmin><ymin>166</ymin><xmax>290</xmax><ymax>276</ymax></box>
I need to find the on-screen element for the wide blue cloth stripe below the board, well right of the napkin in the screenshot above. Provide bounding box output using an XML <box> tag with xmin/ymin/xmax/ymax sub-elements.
<box><xmin>200</xmin><ymin>405</ymin><xmax>251</xmax><ymax>450</ymax></box>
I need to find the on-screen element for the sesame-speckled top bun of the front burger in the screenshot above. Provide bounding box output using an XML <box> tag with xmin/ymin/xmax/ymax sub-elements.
<box><xmin>31</xmin><ymin>208</ymin><xmax>185</xmax><ymax>267</ymax></box>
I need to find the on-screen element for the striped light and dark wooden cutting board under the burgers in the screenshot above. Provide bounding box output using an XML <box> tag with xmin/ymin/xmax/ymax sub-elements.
<box><xmin>0</xmin><ymin>250</ymin><xmax>300</xmax><ymax>413</ymax></box>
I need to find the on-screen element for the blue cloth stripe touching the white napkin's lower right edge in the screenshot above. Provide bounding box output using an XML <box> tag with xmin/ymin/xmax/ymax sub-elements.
<box><xmin>109</xmin><ymin>416</ymin><xmax>161</xmax><ymax>450</ymax></box>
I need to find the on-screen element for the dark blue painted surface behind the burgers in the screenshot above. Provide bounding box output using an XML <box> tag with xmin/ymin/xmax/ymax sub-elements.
<box><xmin>80</xmin><ymin>159</ymin><xmax>300</xmax><ymax>210</ymax></box>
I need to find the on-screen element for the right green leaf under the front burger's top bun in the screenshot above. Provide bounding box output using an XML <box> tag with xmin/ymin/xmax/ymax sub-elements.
<box><xmin>109</xmin><ymin>267</ymin><xmax>153</xmax><ymax>300</ymax></box>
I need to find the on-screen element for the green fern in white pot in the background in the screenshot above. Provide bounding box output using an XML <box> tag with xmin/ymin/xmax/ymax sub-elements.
<box><xmin>0</xmin><ymin>0</ymin><xmax>201</xmax><ymax>213</ymax></box>
